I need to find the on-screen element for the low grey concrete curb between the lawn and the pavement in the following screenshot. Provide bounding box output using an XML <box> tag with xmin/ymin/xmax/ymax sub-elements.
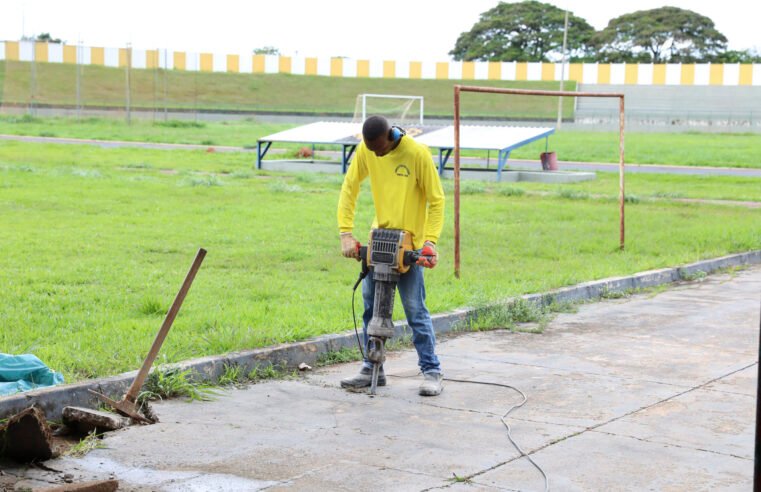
<box><xmin>0</xmin><ymin>250</ymin><xmax>761</xmax><ymax>420</ymax></box>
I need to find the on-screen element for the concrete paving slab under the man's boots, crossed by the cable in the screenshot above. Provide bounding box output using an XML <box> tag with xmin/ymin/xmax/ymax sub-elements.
<box><xmin>314</xmin><ymin>352</ymin><xmax>687</xmax><ymax>428</ymax></box>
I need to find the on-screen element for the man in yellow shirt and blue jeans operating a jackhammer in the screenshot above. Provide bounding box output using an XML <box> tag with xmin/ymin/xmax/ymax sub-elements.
<box><xmin>338</xmin><ymin>116</ymin><xmax>444</xmax><ymax>396</ymax></box>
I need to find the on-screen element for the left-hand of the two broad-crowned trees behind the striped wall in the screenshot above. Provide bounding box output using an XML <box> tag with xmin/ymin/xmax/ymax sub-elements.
<box><xmin>449</xmin><ymin>0</ymin><xmax>595</xmax><ymax>61</ymax></box>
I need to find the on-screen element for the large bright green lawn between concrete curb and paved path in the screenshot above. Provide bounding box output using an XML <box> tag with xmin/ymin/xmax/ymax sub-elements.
<box><xmin>0</xmin><ymin>142</ymin><xmax>761</xmax><ymax>381</ymax></box>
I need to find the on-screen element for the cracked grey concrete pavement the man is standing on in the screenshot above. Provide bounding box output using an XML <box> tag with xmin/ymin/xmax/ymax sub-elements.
<box><xmin>7</xmin><ymin>266</ymin><xmax>761</xmax><ymax>491</ymax></box>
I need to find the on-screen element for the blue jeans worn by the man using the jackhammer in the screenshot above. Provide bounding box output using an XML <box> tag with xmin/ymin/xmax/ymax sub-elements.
<box><xmin>362</xmin><ymin>265</ymin><xmax>441</xmax><ymax>374</ymax></box>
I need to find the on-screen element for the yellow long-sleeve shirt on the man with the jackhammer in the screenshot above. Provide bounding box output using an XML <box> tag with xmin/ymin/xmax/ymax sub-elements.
<box><xmin>338</xmin><ymin>136</ymin><xmax>444</xmax><ymax>249</ymax></box>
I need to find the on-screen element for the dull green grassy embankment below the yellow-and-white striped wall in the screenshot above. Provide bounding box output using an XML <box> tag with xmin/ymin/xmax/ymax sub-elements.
<box><xmin>0</xmin><ymin>61</ymin><xmax>576</xmax><ymax>119</ymax></box>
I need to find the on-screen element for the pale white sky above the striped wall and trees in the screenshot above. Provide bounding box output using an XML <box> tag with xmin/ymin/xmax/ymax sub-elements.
<box><xmin>0</xmin><ymin>0</ymin><xmax>761</xmax><ymax>61</ymax></box>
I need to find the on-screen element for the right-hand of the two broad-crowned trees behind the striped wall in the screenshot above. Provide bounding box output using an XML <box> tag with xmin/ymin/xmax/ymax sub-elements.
<box><xmin>593</xmin><ymin>7</ymin><xmax>727</xmax><ymax>63</ymax></box>
